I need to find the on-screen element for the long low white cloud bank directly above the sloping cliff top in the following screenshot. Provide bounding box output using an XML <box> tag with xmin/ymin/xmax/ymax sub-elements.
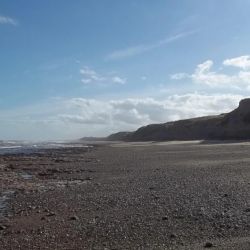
<box><xmin>110</xmin><ymin>93</ymin><xmax>242</xmax><ymax>125</ymax></box>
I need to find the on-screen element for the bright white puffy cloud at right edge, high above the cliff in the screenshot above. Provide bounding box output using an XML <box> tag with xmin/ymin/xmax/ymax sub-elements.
<box><xmin>170</xmin><ymin>56</ymin><xmax>250</xmax><ymax>89</ymax></box>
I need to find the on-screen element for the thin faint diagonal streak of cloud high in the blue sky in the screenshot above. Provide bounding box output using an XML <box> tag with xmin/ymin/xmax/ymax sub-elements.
<box><xmin>106</xmin><ymin>31</ymin><xmax>197</xmax><ymax>60</ymax></box>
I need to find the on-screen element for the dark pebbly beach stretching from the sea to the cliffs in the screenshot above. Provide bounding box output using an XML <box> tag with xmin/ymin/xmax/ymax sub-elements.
<box><xmin>0</xmin><ymin>142</ymin><xmax>250</xmax><ymax>250</ymax></box>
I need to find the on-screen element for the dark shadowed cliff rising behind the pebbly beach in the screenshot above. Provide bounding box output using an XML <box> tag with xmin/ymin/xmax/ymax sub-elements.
<box><xmin>109</xmin><ymin>99</ymin><xmax>250</xmax><ymax>141</ymax></box>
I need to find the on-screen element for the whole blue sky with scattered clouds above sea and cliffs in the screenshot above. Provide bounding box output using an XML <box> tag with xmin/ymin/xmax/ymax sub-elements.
<box><xmin>0</xmin><ymin>0</ymin><xmax>250</xmax><ymax>140</ymax></box>
